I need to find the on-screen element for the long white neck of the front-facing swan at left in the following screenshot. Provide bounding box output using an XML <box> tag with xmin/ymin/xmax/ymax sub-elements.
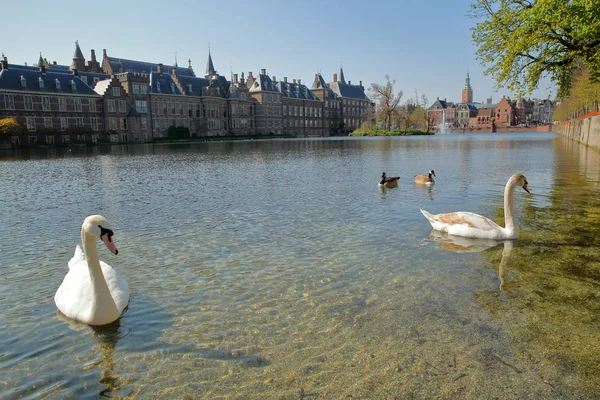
<box><xmin>81</xmin><ymin>229</ymin><xmax>119</xmax><ymax>325</ymax></box>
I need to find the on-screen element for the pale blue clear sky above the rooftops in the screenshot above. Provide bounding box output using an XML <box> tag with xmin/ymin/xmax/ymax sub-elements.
<box><xmin>0</xmin><ymin>0</ymin><xmax>555</xmax><ymax>104</ymax></box>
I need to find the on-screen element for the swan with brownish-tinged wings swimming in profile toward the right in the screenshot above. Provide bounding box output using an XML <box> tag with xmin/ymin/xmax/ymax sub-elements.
<box><xmin>421</xmin><ymin>174</ymin><xmax>529</xmax><ymax>239</ymax></box>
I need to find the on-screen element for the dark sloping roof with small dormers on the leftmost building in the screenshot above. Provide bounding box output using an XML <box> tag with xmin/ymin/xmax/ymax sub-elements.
<box><xmin>0</xmin><ymin>68</ymin><xmax>97</xmax><ymax>96</ymax></box>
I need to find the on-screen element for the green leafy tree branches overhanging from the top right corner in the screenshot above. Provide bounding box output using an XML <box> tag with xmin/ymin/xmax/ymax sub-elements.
<box><xmin>470</xmin><ymin>0</ymin><xmax>600</xmax><ymax>97</ymax></box>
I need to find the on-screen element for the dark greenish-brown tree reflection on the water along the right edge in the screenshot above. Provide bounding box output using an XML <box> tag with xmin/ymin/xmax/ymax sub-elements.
<box><xmin>476</xmin><ymin>154</ymin><xmax>600</xmax><ymax>396</ymax></box>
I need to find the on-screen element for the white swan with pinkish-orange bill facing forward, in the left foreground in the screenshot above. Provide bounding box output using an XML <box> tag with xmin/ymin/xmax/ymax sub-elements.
<box><xmin>54</xmin><ymin>215</ymin><xmax>129</xmax><ymax>325</ymax></box>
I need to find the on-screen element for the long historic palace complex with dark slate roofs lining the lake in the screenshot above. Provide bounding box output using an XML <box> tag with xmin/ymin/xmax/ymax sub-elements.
<box><xmin>0</xmin><ymin>42</ymin><xmax>374</xmax><ymax>144</ymax></box>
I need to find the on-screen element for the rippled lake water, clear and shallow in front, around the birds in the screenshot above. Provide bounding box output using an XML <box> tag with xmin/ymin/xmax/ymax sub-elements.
<box><xmin>0</xmin><ymin>133</ymin><xmax>600</xmax><ymax>399</ymax></box>
